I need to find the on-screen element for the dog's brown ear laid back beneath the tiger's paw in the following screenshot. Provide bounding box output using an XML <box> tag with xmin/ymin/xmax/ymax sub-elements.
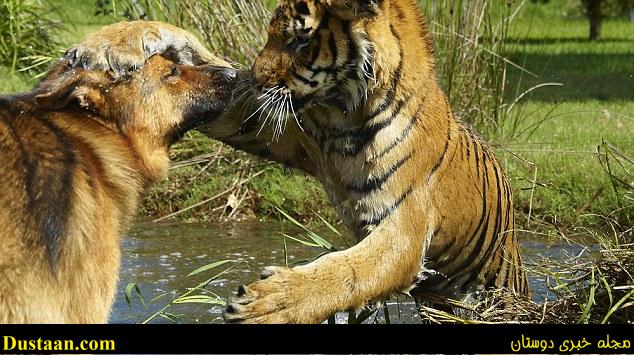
<box><xmin>35</xmin><ymin>70</ymin><xmax>104</xmax><ymax>111</ymax></box>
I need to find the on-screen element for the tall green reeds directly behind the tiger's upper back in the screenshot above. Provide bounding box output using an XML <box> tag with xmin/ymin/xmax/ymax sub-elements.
<box><xmin>419</xmin><ymin>0</ymin><xmax>520</xmax><ymax>128</ymax></box>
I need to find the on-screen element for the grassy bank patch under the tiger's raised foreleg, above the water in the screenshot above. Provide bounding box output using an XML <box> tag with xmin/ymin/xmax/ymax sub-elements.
<box><xmin>142</xmin><ymin>132</ymin><xmax>336</xmax><ymax>221</ymax></box>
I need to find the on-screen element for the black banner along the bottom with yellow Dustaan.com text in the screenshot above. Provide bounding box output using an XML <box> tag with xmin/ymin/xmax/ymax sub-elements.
<box><xmin>0</xmin><ymin>324</ymin><xmax>634</xmax><ymax>354</ymax></box>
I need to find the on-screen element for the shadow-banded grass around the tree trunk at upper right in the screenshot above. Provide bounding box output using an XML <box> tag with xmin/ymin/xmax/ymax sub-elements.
<box><xmin>509</xmin><ymin>16</ymin><xmax>634</xmax><ymax>102</ymax></box>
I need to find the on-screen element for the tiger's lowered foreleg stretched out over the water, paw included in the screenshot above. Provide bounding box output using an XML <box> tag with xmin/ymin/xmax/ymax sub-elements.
<box><xmin>225</xmin><ymin>211</ymin><xmax>426</xmax><ymax>323</ymax></box>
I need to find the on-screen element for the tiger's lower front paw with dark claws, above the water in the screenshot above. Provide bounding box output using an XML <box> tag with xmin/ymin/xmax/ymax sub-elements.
<box><xmin>224</xmin><ymin>267</ymin><xmax>329</xmax><ymax>323</ymax></box>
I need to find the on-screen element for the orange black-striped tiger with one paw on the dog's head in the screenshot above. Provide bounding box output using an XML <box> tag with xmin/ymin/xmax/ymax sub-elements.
<box><xmin>66</xmin><ymin>0</ymin><xmax>530</xmax><ymax>323</ymax></box>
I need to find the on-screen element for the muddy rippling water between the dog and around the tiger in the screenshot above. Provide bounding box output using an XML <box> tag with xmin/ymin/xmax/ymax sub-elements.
<box><xmin>110</xmin><ymin>222</ymin><xmax>582</xmax><ymax>323</ymax></box>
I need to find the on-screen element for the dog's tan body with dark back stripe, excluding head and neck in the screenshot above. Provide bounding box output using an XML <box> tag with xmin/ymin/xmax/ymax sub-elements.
<box><xmin>0</xmin><ymin>95</ymin><xmax>126</xmax><ymax>323</ymax></box>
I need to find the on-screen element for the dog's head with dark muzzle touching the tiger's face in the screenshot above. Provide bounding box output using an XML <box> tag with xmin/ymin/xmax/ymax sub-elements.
<box><xmin>35</xmin><ymin>56</ymin><xmax>236</xmax><ymax>148</ymax></box>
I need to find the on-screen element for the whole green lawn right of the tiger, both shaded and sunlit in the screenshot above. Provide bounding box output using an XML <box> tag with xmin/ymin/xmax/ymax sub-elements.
<box><xmin>491</xmin><ymin>4</ymin><xmax>634</xmax><ymax>225</ymax></box>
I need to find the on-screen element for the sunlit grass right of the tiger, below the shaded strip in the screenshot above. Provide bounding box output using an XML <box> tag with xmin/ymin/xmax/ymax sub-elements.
<box><xmin>494</xmin><ymin>101</ymin><xmax>634</xmax><ymax>225</ymax></box>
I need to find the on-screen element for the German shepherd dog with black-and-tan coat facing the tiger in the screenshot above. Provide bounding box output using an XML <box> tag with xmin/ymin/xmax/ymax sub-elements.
<box><xmin>0</xmin><ymin>56</ymin><xmax>236</xmax><ymax>323</ymax></box>
